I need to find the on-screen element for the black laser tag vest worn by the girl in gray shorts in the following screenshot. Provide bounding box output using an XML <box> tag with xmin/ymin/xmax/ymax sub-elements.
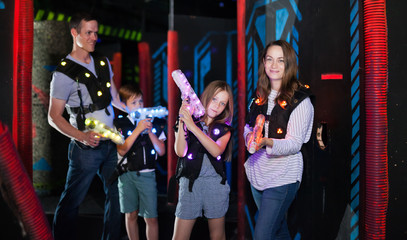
<box><xmin>175</xmin><ymin>123</ymin><xmax>232</xmax><ymax>192</ymax></box>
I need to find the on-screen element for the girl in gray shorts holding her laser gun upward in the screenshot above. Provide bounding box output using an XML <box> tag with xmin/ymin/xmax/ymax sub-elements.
<box><xmin>173</xmin><ymin>81</ymin><xmax>233</xmax><ymax>240</ymax></box>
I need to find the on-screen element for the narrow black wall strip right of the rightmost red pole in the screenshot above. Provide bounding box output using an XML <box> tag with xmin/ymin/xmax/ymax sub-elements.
<box><xmin>386</xmin><ymin>0</ymin><xmax>407</xmax><ymax>239</ymax></box>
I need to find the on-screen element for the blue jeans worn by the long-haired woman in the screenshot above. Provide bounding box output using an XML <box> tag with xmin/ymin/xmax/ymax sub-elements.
<box><xmin>251</xmin><ymin>182</ymin><xmax>300</xmax><ymax>240</ymax></box>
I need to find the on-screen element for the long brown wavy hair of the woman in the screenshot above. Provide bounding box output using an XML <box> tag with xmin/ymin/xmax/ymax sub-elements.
<box><xmin>256</xmin><ymin>40</ymin><xmax>301</xmax><ymax>105</ymax></box>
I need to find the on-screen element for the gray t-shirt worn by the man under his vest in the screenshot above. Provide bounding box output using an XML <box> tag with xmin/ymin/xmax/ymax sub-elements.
<box><xmin>50</xmin><ymin>54</ymin><xmax>114</xmax><ymax>128</ymax></box>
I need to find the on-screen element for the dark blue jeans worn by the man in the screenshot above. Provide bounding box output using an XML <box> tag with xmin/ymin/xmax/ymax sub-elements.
<box><xmin>53</xmin><ymin>141</ymin><xmax>121</xmax><ymax>240</ymax></box>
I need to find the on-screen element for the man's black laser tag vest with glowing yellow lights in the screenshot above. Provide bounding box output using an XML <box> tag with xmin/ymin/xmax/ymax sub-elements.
<box><xmin>56</xmin><ymin>57</ymin><xmax>112</xmax><ymax>130</ymax></box>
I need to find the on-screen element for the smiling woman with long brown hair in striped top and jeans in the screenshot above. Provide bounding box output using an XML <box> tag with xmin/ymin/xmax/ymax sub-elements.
<box><xmin>244</xmin><ymin>40</ymin><xmax>314</xmax><ymax>240</ymax></box>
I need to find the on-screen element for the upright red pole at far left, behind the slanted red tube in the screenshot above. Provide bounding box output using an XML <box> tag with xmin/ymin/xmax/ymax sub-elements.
<box><xmin>12</xmin><ymin>0</ymin><xmax>34</xmax><ymax>179</ymax></box>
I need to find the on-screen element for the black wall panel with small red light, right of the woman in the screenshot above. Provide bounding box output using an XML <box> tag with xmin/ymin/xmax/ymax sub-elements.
<box><xmin>296</xmin><ymin>0</ymin><xmax>357</xmax><ymax>239</ymax></box>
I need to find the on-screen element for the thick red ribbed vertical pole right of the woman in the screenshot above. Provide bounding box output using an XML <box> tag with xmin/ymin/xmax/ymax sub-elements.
<box><xmin>363</xmin><ymin>0</ymin><xmax>389</xmax><ymax>239</ymax></box>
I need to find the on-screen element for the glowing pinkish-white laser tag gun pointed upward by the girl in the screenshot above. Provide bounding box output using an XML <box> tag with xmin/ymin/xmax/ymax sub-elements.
<box><xmin>171</xmin><ymin>69</ymin><xmax>205</xmax><ymax>118</ymax></box>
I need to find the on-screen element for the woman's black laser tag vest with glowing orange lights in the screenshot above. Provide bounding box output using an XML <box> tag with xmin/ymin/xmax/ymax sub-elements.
<box><xmin>246</xmin><ymin>88</ymin><xmax>311</xmax><ymax>139</ymax></box>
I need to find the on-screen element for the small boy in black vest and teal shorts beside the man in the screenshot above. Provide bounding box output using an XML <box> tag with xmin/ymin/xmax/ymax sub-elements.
<box><xmin>114</xmin><ymin>85</ymin><xmax>166</xmax><ymax>240</ymax></box>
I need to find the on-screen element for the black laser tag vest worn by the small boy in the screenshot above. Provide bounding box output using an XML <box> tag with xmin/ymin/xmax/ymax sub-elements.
<box><xmin>114</xmin><ymin>117</ymin><xmax>166</xmax><ymax>171</ymax></box>
